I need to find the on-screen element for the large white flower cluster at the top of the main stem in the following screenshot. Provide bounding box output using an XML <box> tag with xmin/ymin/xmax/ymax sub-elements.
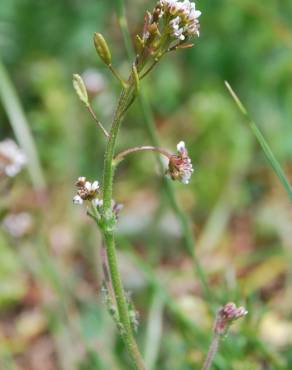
<box><xmin>157</xmin><ymin>0</ymin><xmax>201</xmax><ymax>41</ymax></box>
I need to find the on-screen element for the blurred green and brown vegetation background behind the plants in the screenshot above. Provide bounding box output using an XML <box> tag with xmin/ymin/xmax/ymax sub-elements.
<box><xmin>0</xmin><ymin>0</ymin><xmax>292</xmax><ymax>370</ymax></box>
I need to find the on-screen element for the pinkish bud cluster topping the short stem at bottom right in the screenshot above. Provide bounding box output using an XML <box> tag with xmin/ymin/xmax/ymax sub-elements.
<box><xmin>214</xmin><ymin>302</ymin><xmax>248</xmax><ymax>335</ymax></box>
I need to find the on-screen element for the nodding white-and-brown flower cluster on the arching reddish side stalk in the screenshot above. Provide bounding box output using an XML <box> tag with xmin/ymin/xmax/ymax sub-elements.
<box><xmin>167</xmin><ymin>141</ymin><xmax>194</xmax><ymax>184</ymax></box>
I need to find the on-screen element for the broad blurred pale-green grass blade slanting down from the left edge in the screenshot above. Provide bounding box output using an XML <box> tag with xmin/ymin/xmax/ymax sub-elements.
<box><xmin>0</xmin><ymin>60</ymin><xmax>45</xmax><ymax>190</ymax></box>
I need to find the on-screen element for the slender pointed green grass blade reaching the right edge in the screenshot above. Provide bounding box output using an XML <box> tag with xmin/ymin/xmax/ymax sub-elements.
<box><xmin>225</xmin><ymin>81</ymin><xmax>292</xmax><ymax>201</ymax></box>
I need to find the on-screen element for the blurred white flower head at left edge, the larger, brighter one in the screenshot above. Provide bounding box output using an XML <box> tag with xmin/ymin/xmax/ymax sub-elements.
<box><xmin>0</xmin><ymin>139</ymin><xmax>26</xmax><ymax>177</ymax></box>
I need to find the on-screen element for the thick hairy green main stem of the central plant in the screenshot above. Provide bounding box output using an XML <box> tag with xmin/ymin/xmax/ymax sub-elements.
<box><xmin>103</xmin><ymin>76</ymin><xmax>146</xmax><ymax>370</ymax></box>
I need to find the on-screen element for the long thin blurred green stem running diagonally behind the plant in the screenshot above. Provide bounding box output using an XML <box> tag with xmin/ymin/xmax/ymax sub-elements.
<box><xmin>115</xmin><ymin>0</ymin><xmax>213</xmax><ymax>302</ymax></box>
